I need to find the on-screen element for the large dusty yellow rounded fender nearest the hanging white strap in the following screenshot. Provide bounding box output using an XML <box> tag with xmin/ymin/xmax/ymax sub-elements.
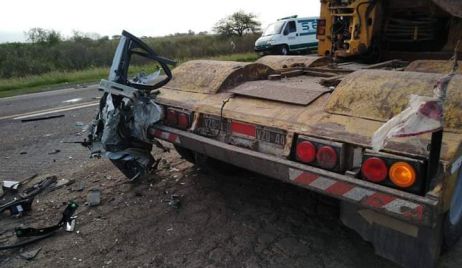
<box><xmin>326</xmin><ymin>70</ymin><xmax>462</xmax><ymax>131</ymax></box>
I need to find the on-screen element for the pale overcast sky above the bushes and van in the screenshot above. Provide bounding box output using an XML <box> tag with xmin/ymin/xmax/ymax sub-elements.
<box><xmin>0</xmin><ymin>0</ymin><xmax>320</xmax><ymax>43</ymax></box>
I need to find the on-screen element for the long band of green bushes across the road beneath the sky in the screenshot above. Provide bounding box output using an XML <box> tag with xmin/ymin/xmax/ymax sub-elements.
<box><xmin>0</xmin><ymin>34</ymin><xmax>258</xmax><ymax>78</ymax></box>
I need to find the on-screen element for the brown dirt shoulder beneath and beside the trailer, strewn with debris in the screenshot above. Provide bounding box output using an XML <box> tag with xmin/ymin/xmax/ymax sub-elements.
<box><xmin>0</xmin><ymin>142</ymin><xmax>457</xmax><ymax>267</ymax></box>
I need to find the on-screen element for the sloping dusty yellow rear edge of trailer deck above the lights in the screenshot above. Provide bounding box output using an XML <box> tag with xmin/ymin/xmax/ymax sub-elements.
<box><xmin>158</xmin><ymin>78</ymin><xmax>462</xmax><ymax>161</ymax></box>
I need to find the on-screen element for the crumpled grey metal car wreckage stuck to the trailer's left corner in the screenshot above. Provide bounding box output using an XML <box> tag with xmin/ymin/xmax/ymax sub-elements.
<box><xmin>86</xmin><ymin>31</ymin><xmax>175</xmax><ymax>180</ymax></box>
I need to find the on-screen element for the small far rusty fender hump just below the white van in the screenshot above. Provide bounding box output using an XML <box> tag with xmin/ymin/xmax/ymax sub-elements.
<box><xmin>255</xmin><ymin>56</ymin><xmax>329</xmax><ymax>70</ymax></box>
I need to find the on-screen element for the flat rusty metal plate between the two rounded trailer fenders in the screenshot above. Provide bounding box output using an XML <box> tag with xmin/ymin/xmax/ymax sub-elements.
<box><xmin>230</xmin><ymin>77</ymin><xmax>329</xmax><ymax>105</ymax></box>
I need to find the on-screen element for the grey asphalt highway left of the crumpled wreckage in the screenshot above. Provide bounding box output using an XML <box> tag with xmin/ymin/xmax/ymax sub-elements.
<box><xmin>0</xmin><ymin>86</ymin><xmax>101</xmax><ymax>180</ymax></box>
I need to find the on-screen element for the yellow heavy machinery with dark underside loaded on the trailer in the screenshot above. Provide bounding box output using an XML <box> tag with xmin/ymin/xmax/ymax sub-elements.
<box><xmin>317</xmin><ymin>0</ymin><xmax>462</xmax><ymax>61</ymax></box>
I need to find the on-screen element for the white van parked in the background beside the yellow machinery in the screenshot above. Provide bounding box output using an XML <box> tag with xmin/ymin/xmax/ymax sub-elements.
<box><xmin>255</xmin><ymin>16</ymin><xmax>318</xmax><ymax>55</ymax></box>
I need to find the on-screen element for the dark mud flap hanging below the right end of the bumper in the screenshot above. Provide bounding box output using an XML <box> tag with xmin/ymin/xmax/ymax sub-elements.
<box><xmin>340</xmin><ymin>202</ymin><xmax>442</xmax><ymax>268</ymax></box>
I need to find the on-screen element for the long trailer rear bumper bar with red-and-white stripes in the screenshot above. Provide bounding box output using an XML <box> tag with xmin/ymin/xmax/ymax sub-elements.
<box><xmin>149</xmin><ymin>126</ymin><xmax>439</xmax><ymax>227</ymax></box>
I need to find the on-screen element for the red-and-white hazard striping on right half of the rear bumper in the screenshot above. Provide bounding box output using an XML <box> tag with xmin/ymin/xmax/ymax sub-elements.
<box><xmin>289</xmin><ymin>168</ymin><xmax>425</xmax><ymax>222</ymax></box>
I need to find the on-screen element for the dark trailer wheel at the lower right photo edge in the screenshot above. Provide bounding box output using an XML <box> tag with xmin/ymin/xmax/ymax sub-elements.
<box><xmin>442</xmin><ymin>169</ymin><xmax>462</xmax><ymax>251</ymax></box>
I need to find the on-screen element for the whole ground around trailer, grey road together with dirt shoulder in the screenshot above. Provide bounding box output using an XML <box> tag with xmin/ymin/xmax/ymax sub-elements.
<box><xmin>0</xmin><ymin>86</ymin><xmax>462</xmax><ymax>267</ymax></box>
